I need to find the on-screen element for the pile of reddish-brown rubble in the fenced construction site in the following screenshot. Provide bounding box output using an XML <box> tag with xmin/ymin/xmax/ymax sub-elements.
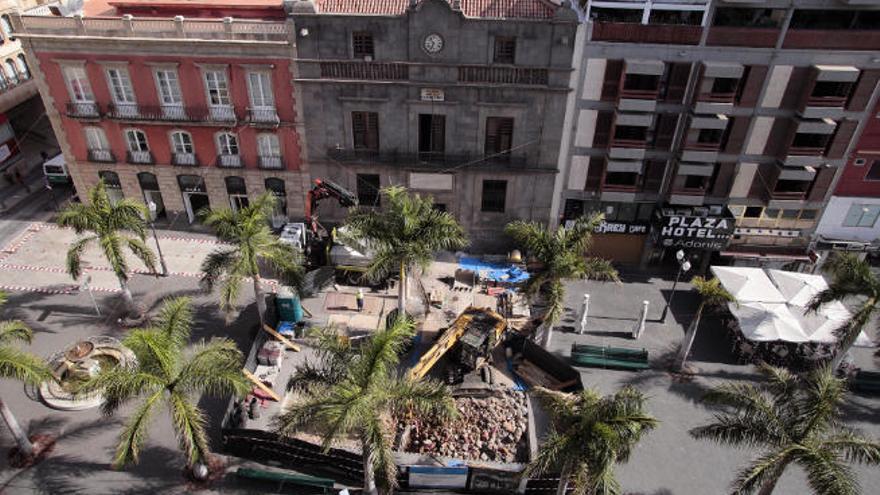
<box><xmin>406</xmin><ymin>390</ymin><xmax>528</xmax><ymax>462</ymax></box>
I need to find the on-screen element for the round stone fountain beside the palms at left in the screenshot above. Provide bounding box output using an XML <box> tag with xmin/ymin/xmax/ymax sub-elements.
<box><xmin>40</xmin><ymin>336</ymin><xmax>136</xmax><ymax>411</ymax></box>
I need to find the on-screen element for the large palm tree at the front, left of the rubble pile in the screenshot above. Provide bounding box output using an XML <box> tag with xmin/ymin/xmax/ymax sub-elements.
<box><xmin>276</xmin><ymin>316</ymin><xmax>456</xmax><ymax>494</ymax></box>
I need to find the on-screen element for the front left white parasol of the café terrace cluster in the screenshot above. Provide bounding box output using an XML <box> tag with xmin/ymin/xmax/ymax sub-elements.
<box><xmin>728</xmin><ymin>302</ymin><xmax>810</xmax><ymax>342</ymax></box>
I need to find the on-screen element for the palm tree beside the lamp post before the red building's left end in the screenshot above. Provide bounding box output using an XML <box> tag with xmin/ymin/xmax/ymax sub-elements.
<box><xmin>58</xmin><ymin>180</ymin><xmax>156</xmax><ymax>310</ymax></box>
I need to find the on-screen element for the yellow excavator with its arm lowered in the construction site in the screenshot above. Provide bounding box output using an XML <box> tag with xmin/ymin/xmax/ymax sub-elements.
<box><xmin>407</xmin><ymin>306</ymin><xmax>507</xmax><ymax>380</ymax></box>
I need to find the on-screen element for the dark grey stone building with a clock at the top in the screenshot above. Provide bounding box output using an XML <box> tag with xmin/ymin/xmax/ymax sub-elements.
<box><xmin>286</xmin><ymin>0</ymin><xmax>577</xmax><ymax>250</ymax></box>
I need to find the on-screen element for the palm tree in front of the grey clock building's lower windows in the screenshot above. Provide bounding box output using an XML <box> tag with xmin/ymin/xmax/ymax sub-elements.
<box><xmin>346</xmin><ymin>186</ymin><xmax>467</xmax><ymax>314</ymax></box>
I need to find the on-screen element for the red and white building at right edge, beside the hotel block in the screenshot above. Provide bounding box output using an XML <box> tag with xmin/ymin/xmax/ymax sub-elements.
<box><xmin>814</xmin><ymin>99</ymin><xmax>880</xmax><ymax>264</ymax></box>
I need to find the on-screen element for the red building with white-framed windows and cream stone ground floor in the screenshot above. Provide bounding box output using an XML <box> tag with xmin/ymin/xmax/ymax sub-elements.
<box><xmin>12</xmin><ymin>0</ymin><xmax>308</xmax><ymax>227</ymax></box>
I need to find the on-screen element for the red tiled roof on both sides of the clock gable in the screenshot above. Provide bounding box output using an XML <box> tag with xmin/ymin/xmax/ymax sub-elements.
<box><xmin>315</xmin><ymin>0</ymin><xmax>557</xmax><ymax>19</ymax></box>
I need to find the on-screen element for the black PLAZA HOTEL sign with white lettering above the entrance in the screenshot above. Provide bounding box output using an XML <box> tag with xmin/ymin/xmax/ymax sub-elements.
<box><xmin>655</xmin><ymin>208</ymin><xmax>736</xmax><ymax>251</ymax></box>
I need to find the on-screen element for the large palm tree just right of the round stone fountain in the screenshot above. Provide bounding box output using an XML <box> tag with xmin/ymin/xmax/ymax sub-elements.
<box><xmin>81</xmin><ymin>298</ymin><xmax>250</xmax><ymax>467</ymax></box>
